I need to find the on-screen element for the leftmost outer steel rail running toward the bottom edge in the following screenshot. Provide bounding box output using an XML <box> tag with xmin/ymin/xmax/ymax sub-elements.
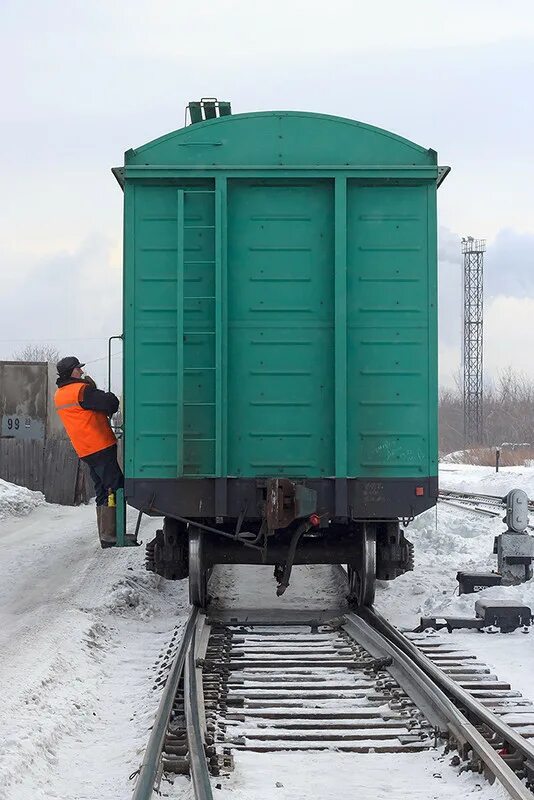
<box><xmin>132</xmin><ymin>608</ymin><xmax>199</xmax><ymax>800</ymax></box>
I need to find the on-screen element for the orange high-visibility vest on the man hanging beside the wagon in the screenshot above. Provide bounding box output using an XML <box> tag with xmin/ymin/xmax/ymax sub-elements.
<box><xmin>54</xmin><ymin>383</ymin><xmax>117</xmax><ymax>458</ymax></box>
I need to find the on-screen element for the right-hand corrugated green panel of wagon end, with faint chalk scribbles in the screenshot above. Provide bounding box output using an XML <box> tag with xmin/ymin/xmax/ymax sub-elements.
<box><xmin>347</xmin><ymin>182</ymin><xmax>437</xmax><ymax>477</ymax></box>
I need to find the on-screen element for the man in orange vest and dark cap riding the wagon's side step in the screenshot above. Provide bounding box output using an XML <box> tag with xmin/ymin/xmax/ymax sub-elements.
<box><xmin>54</xmin><ymin>356</ymin><xmax>133</xmax><ymax>547</ymax></box>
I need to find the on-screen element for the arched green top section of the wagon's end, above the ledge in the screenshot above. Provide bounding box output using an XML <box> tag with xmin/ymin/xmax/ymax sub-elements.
<box><xmin>125</xmin><ymin>111</ymin><xmax>437</xmax><ymax>166</ymax></box>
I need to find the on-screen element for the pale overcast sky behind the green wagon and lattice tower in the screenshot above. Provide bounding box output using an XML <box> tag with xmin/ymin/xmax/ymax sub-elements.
<box><xmin>0</xmin><ymin>0</ymin><xmax>534</xmax><ymax>383</ymax></box>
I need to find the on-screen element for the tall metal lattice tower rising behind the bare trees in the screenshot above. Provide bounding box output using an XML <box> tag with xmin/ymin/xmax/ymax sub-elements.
<box><xmin>462</xmin><ymin>236</ymin><xmax>486</xmax><ymax>446</ymax></box>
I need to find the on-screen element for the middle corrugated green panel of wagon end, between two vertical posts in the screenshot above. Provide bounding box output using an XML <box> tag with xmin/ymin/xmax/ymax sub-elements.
<box><xmin>228</xmin><ymin>182</ymin><xmax>334</xmax><ymax>476</ymax></box>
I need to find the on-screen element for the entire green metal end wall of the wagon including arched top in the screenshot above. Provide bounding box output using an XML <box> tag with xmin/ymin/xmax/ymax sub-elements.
<box><xmin>124</xmin><ymin>114</ymin><xmax>437</xmax><ymax>478</ymax></box>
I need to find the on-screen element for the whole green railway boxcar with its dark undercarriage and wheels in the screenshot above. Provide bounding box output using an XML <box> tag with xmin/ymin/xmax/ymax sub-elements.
<box><xmin>114</xmin><ymin>102</ymin><xmax>448</xmax><ymax>604</ymax></box>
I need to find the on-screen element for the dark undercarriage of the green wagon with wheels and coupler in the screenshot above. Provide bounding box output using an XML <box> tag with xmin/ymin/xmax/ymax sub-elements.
<box><xmin>146</xmin><ymin>479</ymin><xmax>413</xmax><ymax>607</ymax></box>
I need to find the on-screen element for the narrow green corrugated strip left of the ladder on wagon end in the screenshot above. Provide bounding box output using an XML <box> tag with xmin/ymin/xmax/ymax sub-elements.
<box><xmin>130</xmin><ymin>186</ymin><xmax>177</xmax><ymax>477</ymax></box>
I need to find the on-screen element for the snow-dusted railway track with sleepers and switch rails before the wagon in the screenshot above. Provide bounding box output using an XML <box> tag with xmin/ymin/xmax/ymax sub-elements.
<box><xmin>132</xmin><ymin>572</ymin><xmax>534</xmax><ymax>800</ymax></box>
